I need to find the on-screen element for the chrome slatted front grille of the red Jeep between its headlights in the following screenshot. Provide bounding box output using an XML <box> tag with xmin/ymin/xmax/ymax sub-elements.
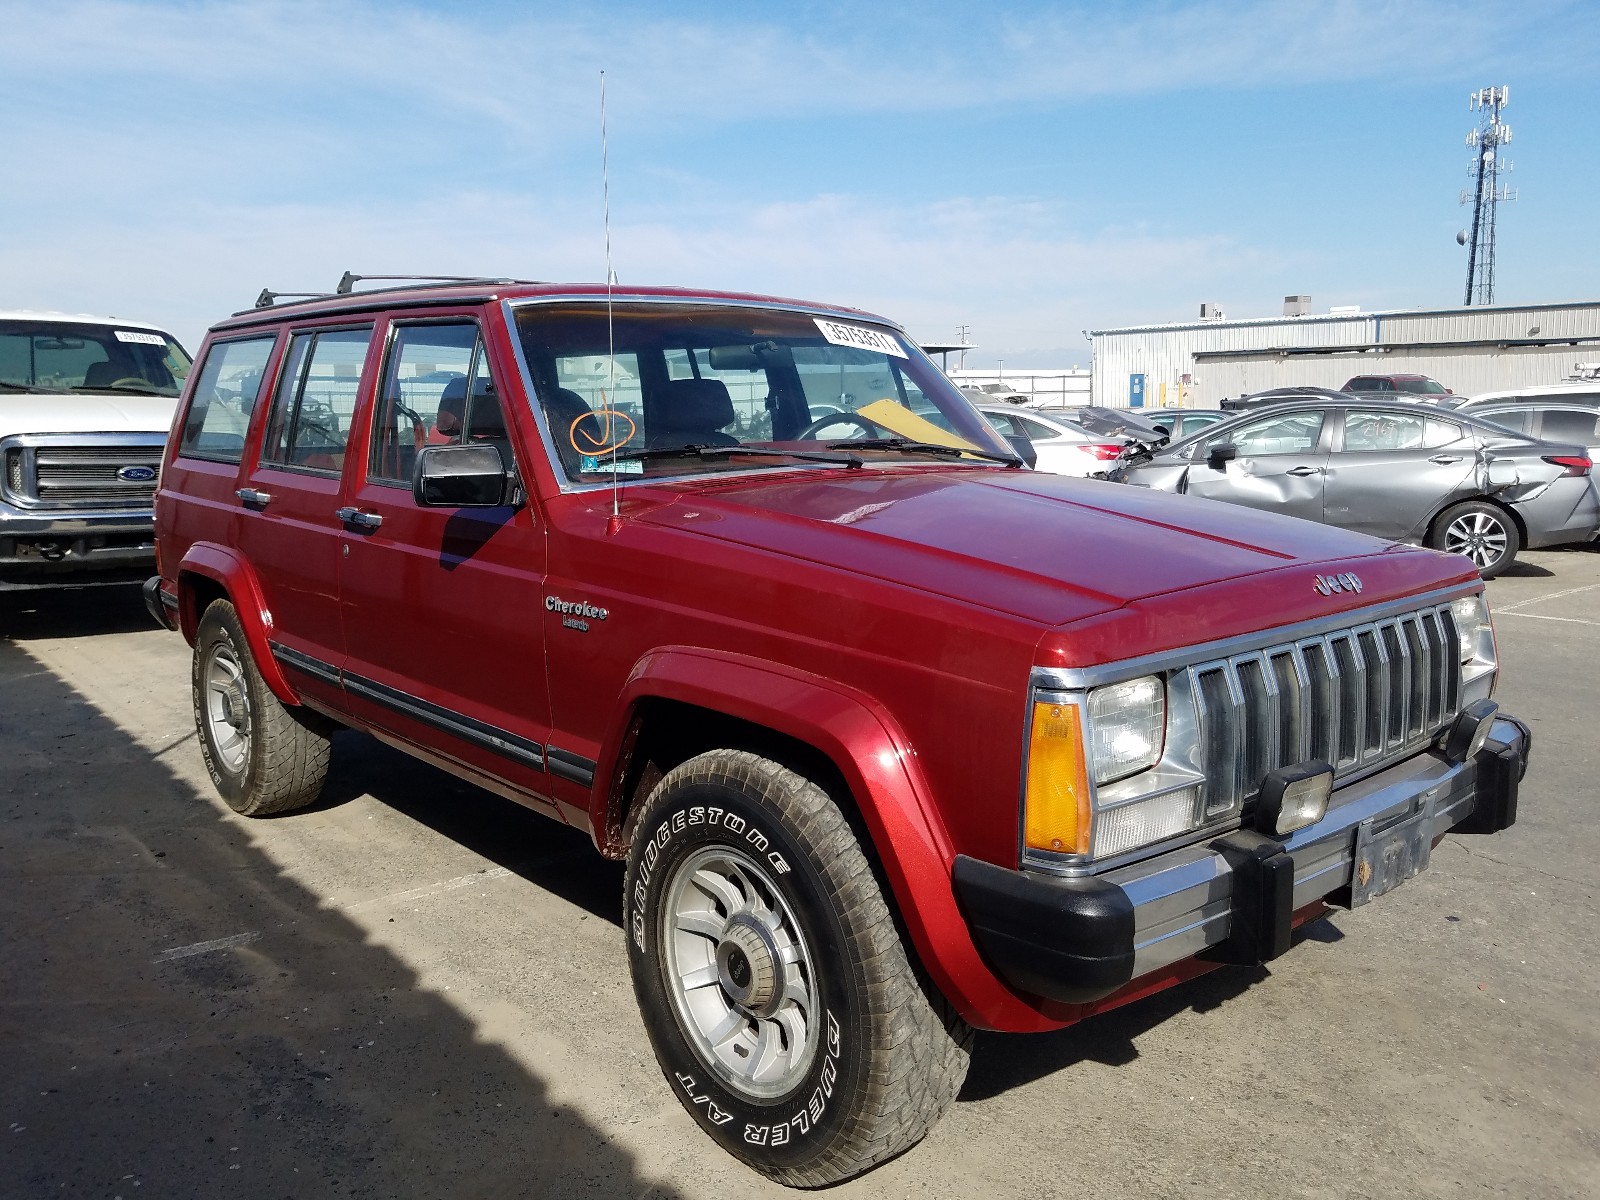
<box><xmin>1186</xmin><ymin>605</ymin><xmax>1461</xmax><ymax>814</ymax></box>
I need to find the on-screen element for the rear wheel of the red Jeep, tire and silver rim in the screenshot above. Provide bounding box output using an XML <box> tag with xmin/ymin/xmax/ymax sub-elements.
<box><xmin>190</xmin><ymin>600</ymin><xmax>331</xmax><ymax>816</ymax></box>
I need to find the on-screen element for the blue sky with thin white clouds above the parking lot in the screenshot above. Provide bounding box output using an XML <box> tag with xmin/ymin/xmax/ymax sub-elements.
<box><xmin>0</xmin><ymin>0</ymin><xmax>1600</xmax><ymax>366</ymax></box>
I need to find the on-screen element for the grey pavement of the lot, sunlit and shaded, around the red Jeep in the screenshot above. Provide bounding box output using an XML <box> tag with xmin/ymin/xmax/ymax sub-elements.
<box><xmin>0</xmin><ymin>549</ymin><xmax>1600</xmax><ymax>1200</ymax></box>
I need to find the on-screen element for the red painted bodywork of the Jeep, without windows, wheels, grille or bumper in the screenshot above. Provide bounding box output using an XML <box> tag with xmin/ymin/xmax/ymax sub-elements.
<box><xmin>157</xmin><ymin>285</ymin><xmax>1475</xmax><ymax>1032</ymax></box>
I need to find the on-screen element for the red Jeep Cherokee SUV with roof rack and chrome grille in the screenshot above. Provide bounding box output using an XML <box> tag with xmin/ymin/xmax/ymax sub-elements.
<box><xmin>146</xmin><ymin>280</ymin><xmax>1528</xmax><ymax>1186</ymax></box>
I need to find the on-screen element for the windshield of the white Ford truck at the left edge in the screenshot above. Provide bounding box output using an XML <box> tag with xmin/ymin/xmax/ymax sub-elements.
<box><xmin>0</xmin><ymin>318</ymin><xmax>189</xmax><ymax>395</ymax></box>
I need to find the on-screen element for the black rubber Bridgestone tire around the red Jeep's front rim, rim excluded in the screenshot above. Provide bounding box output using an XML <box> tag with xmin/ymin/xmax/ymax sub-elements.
<box><xmin>622</xmin><ymin>750</ymin><xmax>971</xmax><ymax>1187</ymax></box>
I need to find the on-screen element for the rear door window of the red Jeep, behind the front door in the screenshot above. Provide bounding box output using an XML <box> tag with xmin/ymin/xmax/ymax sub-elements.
<box><xmin>261</xmin><ymin>334</ymin><xmax>373</xmax><ymax>475</ymax></box>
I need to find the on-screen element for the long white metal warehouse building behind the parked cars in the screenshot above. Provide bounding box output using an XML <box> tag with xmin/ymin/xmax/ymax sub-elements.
<box><xmin>1090</xmin><ymin>298</ymin><xmax>1600</xmax><ymax>408</ymax></box>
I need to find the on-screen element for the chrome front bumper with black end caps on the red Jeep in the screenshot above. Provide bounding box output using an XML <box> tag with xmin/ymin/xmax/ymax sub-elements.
<box><xmin>954</xmin><ymin>715</ymin><xmax>1531</xmax><ymax>1003</ymax></box>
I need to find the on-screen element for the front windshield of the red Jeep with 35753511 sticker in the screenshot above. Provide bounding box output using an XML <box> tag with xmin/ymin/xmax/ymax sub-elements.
<box><xmin>517</xmin><ymin>302</ymin><xmax>1014</xmax><ymax>483</ymax></box>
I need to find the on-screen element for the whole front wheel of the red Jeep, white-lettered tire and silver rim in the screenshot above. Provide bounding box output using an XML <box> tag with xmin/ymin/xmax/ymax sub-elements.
<box><xmin>624</xmin><ymin>750</ymin><xmax>973</xmax><ymax>1187</ymax></box>
